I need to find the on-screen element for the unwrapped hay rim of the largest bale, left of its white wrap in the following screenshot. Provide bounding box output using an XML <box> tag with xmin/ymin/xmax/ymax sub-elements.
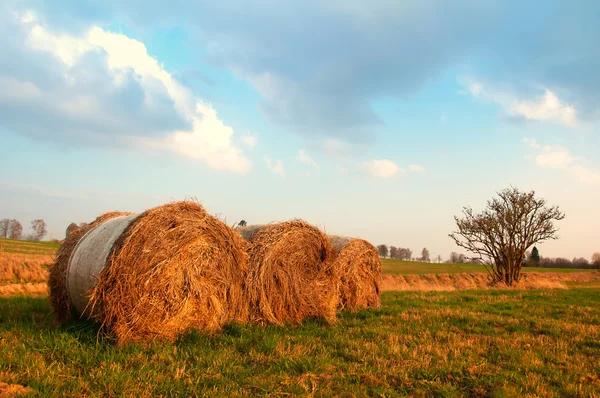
<box><xmin>48</xmin><ymin>211</ymin><xmax>133</xmax><ymax>323</ymax></box>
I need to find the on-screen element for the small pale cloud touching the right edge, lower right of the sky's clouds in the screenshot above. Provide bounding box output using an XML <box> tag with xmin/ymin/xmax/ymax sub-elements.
<box><xmin>523</xmin><ymin>138</ymin><xmax>600</xmax><ymax>185</ymax></box>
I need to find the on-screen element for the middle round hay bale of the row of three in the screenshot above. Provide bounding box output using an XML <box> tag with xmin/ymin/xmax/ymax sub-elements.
<box><xmin>247</xmin><ymin>220</ymin><xmax>338</xmax><ymax>325</ymax></box>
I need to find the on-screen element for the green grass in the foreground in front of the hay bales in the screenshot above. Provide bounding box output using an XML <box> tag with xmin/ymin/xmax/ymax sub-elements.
<box><xmin>0</xmin><ymin>289</ymin><xmax>600</xmax><ymax>397</ymax></box>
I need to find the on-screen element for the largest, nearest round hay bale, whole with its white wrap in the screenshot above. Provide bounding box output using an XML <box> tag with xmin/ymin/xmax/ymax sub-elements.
<box><xmin>49</xmin><ymin>202</ymin><xmax>248</xmax><ymax>343</ymax></box>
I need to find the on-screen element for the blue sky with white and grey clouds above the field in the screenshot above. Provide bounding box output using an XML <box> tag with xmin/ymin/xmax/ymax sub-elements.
<box><xmin>0</xmin><ymin>0</ymin><xmax>600</xmax><ymax>259</ymax></box>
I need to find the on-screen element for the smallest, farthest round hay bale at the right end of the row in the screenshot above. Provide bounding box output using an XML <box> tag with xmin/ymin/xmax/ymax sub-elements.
<box><xmin>335</xmin><ymin>239</ymin><xmax>381</xmax><ymax>311</ymax></box>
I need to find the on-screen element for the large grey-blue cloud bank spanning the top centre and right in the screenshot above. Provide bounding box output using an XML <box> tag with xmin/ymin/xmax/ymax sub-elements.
<box><xmin>7</xmin><ymin>0</ymin><xmax>600</xmax><ymax>143</ymax></box>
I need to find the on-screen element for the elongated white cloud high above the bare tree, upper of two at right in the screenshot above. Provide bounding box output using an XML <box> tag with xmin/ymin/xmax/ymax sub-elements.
<box><xmin>458</xmin><ymin>77</ymin><xmax>578</xmax><ymax>127</ymax></box>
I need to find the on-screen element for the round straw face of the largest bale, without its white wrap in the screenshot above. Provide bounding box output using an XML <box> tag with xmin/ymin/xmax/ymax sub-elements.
<box><xmin>87</xmin><ymin>201</ymin><xmax>248</xmax><ymax>343</ymax></box>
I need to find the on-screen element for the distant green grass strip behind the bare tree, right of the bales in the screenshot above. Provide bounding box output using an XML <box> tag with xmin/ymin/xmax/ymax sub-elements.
<box><xmin>382</xmin><ymin>258</ymin><xmax>594</xmax><ymax>275</ymax></box>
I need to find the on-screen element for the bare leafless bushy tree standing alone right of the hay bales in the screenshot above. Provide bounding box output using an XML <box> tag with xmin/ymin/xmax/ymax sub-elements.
<box><xmin>450</xmin><ymin>187</ymin><xmax>565</xmax><ymax>285</ymax></box>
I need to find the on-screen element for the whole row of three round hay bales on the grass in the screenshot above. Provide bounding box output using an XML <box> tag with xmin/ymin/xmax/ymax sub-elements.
<box><xmin>48</xmin><ymin>201</ymin><xmax>381</xmax><ymax>343</ymax></box>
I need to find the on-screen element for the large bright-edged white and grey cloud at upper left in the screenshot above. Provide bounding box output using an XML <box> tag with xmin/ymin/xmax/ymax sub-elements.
<box><xmin>0</xmin><ymin>8</ymin><xmax>251</xmax><ymax>173</ymax></box>
